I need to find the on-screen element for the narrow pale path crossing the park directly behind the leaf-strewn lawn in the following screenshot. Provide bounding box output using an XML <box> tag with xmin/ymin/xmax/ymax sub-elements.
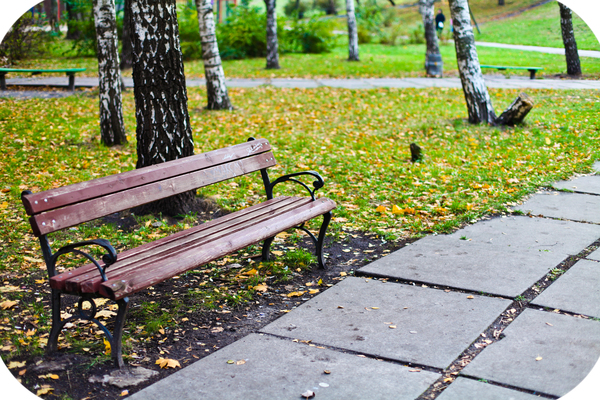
<box><xmin>0</xmin><ymin>72</ymin><xmax>600</xmax><ymax>98</ymax></box>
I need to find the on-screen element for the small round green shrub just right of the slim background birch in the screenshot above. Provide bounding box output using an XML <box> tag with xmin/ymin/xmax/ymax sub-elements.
<box><xmin>285</xmin><ymin>15</ymin><xmax>335</xmax><ymax>54</ymax></box>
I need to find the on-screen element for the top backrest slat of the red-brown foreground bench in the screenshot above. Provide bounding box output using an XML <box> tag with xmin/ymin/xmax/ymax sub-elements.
<box><xmin>23</xmin><ymin>139</ymin><xmax>271</xmax><ymax>215</ymax></box>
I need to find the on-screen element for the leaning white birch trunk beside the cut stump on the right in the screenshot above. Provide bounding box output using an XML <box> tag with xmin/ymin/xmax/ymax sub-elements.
<box><xmin>449</xmin><ymin>0</ymin><xmax>496</xmax><ymax>125</ymax></box>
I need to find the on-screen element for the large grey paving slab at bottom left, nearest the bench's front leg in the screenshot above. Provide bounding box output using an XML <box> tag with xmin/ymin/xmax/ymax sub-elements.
<box><xmin>129</xmin><ymin>334</ymin><xmax>439</xmax><ymax>400</ymax></box>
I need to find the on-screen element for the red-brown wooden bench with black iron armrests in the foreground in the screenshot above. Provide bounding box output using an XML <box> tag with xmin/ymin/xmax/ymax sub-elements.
<box><xmin>21</xmin><ymin>138</ymin><xmax>335</xmax><ymax>367</ymax></box>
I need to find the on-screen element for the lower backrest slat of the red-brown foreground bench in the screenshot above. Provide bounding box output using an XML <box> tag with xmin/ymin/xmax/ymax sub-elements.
<box><xmin>29</xmin><ymin>153</ymin><xmax>275</xmax><ymax>236</ymax></box>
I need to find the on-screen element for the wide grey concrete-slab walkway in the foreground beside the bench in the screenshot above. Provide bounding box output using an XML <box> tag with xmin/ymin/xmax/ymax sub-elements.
<box><xmin>125</xmin><ymin>163</ymin><xmax>600</xmax><ymax>400</ymax></box>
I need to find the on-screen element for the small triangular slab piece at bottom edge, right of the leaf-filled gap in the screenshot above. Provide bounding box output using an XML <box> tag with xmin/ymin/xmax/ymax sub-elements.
<box><xmin>437</xmin><ymin>376</ymin><xmax>540</xmax><ymax>400</ymax></box>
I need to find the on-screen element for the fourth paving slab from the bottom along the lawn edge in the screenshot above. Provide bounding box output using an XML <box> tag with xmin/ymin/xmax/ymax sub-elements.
<box><xmin>514</xmin><ymin>192</ymin><xmax>600</xmax><ymax>224</ymax></box>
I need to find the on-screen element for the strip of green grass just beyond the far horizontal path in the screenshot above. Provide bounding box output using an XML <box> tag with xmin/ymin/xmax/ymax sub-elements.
<box><xmin>9</xmin><ymin>42</ymin><xmax>600</xmax><ymax>79</ymax></box>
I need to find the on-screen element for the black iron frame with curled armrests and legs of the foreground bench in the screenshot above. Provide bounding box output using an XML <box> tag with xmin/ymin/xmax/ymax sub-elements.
<box><xmin>21</xmin><ymin>138</ymin><xmax>335</xmax><ymax>368</ymax></box>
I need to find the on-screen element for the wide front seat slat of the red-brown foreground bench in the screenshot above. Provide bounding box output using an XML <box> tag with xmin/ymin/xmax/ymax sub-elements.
<box><xmin>99</xmin><ymin>198</ymin><xmax>335</xmax><ymax>300</ymax></box>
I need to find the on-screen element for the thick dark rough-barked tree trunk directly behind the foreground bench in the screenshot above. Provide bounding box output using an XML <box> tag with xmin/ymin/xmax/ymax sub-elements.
<box><xmin>128</xmin><ymin>0</ymin><xmax>195</xmax><ymax>215</ymax></box>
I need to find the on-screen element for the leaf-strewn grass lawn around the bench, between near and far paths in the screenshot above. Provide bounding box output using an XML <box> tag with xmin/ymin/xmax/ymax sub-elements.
<box><xmin>0</xmin><ymin>82</ymin><xmax>600</xmax><ymax>394</ymax></box>
